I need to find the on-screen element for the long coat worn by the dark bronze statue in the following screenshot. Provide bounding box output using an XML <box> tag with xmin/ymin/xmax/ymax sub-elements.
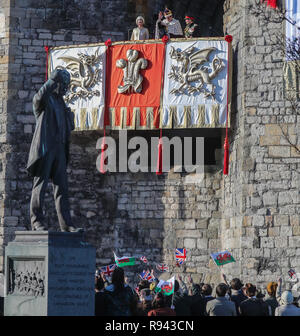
<box><xmin>26</xmin><ymin>79</ymin><xmax>74</xmax><ymax>178</ymax></box>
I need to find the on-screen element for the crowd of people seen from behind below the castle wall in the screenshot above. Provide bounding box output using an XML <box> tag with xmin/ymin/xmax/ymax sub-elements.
<box><xmin>95</xmin><ymin>267</ymin><xmax>300</xmax><ymax>316</ymax></box>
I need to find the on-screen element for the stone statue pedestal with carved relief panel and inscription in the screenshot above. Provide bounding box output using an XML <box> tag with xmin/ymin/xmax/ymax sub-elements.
<box><xmin>4</xmin><ymin>231</ymin><xmax>96</xmax><ymax>316</ymax></box>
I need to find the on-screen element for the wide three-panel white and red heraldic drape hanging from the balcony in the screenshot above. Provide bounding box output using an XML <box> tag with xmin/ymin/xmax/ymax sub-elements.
<box><xmin>48</xmin><ymin>37</ymin><xmax>232</xmax><ymax>131</ymax></box>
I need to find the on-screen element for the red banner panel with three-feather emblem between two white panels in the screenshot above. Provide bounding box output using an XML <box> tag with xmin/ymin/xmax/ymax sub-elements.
<box><xmin>105</xmin><ymin>42</ymin><xmax>164</xmax><ymax>129</ymax></box>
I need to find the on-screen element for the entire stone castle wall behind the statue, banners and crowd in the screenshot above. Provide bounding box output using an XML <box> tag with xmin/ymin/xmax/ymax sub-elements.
<box><xmin>0</xmin><ymin>0</ymin><xmax>300</xmax><ymax>292</ymax></box>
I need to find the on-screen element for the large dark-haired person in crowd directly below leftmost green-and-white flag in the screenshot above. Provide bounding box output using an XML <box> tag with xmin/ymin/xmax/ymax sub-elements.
<box><xmin>104</xmin><ymin>267</ymin><xmax>137</xmax><ymax>316</ymax></box>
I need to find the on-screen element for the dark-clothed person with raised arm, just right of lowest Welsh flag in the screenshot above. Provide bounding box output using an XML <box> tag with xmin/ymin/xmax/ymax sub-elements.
<box><xmin>170</xmin><ymin>275</ymin><xmax>191</xmax><ymax>316</ymax></box>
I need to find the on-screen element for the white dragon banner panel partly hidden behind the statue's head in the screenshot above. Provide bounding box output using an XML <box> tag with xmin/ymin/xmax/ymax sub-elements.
<box><xmin>49</xmin><ymin>45</ymin><xmax>106</xmax><ymax>130</ymax></box>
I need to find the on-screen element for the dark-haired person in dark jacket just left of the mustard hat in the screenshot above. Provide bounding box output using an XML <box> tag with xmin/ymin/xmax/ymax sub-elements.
<box><xmin>239</xmin><ymin>283</ymin><xmax>271</xmax><ymax>316</ymax></box>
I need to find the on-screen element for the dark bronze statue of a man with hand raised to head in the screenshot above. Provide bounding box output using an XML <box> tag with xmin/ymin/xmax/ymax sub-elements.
<box><xmin>27</xmin><ymin>69</ymin><xmax>80</xmax><ymax>232</ymax></box>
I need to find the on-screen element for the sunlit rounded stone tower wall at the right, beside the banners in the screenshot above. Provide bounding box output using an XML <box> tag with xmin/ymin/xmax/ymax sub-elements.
<box><xmin>221</xmin><ymin>1</ymin><xmax>300</xmax><ymax>283</ymax></box>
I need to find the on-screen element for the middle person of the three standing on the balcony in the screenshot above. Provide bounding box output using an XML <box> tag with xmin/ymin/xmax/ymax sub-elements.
<box><xmin>155</xmin><ymin>8</ymin><xmax>183</xmax><ymax>39</ymax></box>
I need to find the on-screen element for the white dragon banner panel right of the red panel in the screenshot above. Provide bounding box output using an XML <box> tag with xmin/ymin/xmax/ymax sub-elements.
<box><xmin>161</xmin><ymin>39</ymin><xmax>229</xmax><ymax>128</ymax></box>
